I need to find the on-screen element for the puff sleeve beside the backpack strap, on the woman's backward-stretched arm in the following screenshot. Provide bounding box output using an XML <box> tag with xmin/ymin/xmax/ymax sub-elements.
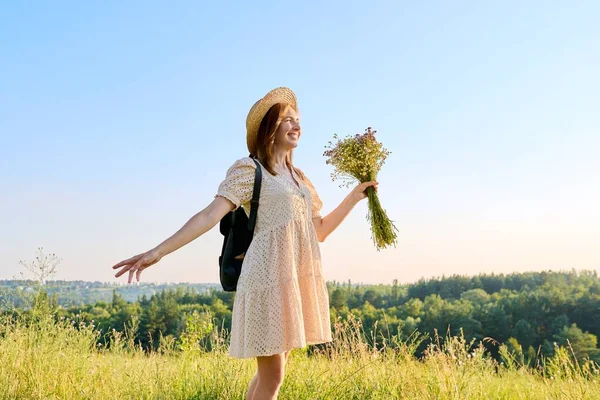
<box><xmin>215</xmin><ymin>157</ymin><xmax>256</xmax><ymax>209</ymax></box>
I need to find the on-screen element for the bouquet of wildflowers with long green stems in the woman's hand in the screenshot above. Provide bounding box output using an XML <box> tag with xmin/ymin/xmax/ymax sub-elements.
<box><xmin>323</xmin><ymin>127</ymin><xmax>398</xmax><ymax>250</ymax></box>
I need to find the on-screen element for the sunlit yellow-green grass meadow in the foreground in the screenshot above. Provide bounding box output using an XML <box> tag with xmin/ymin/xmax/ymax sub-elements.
<box><xmin>0</xmin><ymin>298</ymin><xmax>600</xmax><ymax>400</ymax></box>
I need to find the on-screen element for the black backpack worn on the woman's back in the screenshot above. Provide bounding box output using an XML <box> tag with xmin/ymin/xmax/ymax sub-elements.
<box><xmin>219</xmin><ymin>158</ymin><xmax>262</xmax><ymax>292</ymax></box>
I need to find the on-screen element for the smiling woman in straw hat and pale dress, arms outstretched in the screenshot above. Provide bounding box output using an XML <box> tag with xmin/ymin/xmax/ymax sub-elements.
<box><xmin>113</xmin><ymin>88</ymin><xmax>377</xmax><ymax>399</ymax></box>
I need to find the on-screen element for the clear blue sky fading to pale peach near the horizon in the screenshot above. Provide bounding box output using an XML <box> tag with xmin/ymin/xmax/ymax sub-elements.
<box><xmin>0</xmin><ymin>1</ymin><xmax>600</xmax><ymax>283</ymax></box>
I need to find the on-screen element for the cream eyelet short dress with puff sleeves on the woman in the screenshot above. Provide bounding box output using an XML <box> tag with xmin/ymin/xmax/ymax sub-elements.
<box><xmin>216</xmin><ymin>157</ymin><xmax>332</xmax><ymax>358</ymax></box>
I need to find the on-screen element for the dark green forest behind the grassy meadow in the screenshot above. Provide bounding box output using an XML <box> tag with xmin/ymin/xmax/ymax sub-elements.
<box><xmin>0</xmin><ymin>270</ymin><xmax>600</xmax><ymax>365</ymax></box>
